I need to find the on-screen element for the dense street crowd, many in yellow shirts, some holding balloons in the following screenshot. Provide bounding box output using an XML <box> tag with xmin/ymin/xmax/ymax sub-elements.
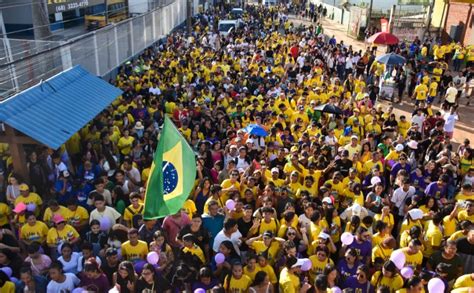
<box><xmin>0</xmin><ymin>2</ymin><xmax>474</xmax><ymax>293</ymax></box>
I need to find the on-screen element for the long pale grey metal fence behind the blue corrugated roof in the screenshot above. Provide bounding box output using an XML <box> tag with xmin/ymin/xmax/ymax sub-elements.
<box><xmin>0</xmin><ymin>0</ymin><xmax>186</xmax><ymax>99</ymax></box>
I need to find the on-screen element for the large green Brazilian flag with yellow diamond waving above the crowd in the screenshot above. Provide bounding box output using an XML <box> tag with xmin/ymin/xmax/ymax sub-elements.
<box><xmin>143</xmin><ymin>117</ymin><xmax>196</xmax><ymax>220</ymax></box>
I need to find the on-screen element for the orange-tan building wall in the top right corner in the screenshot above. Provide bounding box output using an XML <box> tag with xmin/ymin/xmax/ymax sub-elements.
<box><xmin>444</xmin><ymin>1</ymin><xmax>474</xmax><ymax>44</ymax></box>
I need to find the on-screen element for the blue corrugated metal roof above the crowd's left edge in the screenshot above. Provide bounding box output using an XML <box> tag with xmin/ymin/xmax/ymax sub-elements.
<box><xmin>0</xmin><ymin>65</ymin><xmax>122</xmax><ymax>149</ymax></box>
